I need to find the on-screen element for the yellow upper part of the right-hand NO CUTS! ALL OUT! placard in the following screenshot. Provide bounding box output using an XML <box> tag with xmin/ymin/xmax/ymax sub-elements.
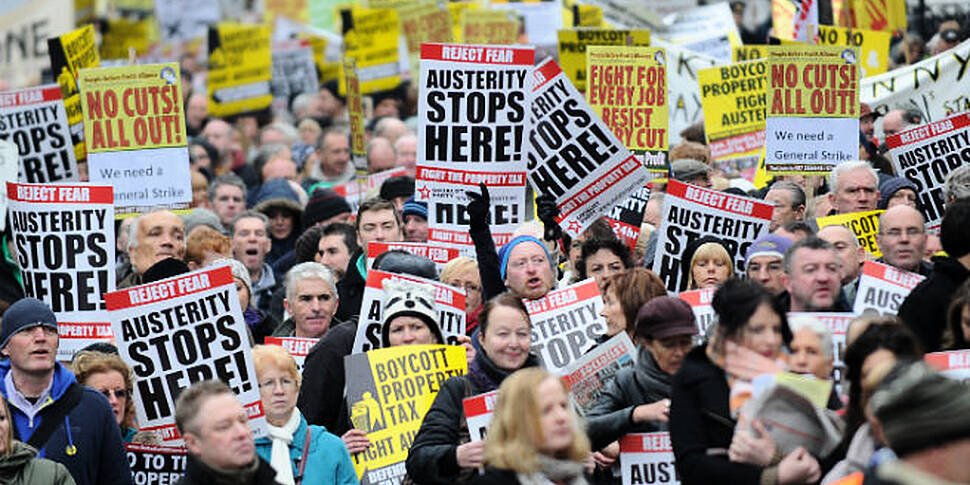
<box><xmin>768</xmin><ymin>45</ymin><xmax>859</xmax><ymax>118</ymax></box>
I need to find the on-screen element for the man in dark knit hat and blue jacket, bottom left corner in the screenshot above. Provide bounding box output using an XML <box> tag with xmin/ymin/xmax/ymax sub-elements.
<box><xmin>0</xmin><ymin>298</ymin><xmax>132</xmax><ymax>485</ymax></box>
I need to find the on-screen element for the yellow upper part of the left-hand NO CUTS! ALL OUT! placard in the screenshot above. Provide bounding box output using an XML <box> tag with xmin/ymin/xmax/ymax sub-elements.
<box><xmin>79</xmin><ymin>63</ymin><xmax>186</xmax><ymax>153</ymax></box>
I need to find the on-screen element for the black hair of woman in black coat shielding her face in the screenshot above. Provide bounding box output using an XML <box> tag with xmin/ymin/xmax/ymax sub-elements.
<box><xmin>711</xmin><ymin>278</ymin><xmax>791</xmax><ymax>345</ymax></box>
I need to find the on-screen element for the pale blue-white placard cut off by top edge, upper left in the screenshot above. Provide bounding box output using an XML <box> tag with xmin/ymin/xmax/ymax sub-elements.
<box><xmin>155</xmin><ymin>0</ymin><xmax>222</xmax><ymax>44</ymax></box>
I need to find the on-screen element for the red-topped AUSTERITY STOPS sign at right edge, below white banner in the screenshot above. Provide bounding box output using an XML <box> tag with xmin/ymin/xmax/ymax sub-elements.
<box><xmin>886</xmin><ymin>113</ymin><xmax>970</xmax><ymax>232</ymax></box>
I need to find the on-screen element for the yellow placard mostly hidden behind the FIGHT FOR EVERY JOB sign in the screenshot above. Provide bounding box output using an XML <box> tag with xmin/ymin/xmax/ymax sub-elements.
<box><xmin>559</xmin><ymin>28</ymin><xmax>650</xmax><ymax>91</ymax></box>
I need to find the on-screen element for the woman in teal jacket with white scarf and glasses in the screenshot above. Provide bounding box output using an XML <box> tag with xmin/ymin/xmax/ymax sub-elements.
<box><xmin>253</xmin><ymin>345</ymin><xmax>359</xmax><ymax>485</ymax></box>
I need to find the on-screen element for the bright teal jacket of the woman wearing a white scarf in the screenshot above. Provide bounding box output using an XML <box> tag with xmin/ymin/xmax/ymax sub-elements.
<box><xmin>256</xmin><ymin>410</ymin><xmax>360</xmax><ymax>485</ymax></box>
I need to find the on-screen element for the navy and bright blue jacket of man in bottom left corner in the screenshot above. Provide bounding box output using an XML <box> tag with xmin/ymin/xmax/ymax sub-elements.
<box><xmin>0</xmin><ymin>360</ymin><xmax>132</xmax><ymax>485</ymax></box>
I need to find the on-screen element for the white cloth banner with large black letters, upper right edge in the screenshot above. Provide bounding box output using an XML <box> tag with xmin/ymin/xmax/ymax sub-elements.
<box><xmin>859</xmin><ymin>40</ymin><xmax>970</xmax><ymax>123</ymax></box>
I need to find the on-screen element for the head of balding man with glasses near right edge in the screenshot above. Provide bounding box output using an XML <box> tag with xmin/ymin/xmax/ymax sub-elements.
<box><xmin>876</xmin><ymin>205</ymin><xmax>933</xmax><ymax>276</ymax></box>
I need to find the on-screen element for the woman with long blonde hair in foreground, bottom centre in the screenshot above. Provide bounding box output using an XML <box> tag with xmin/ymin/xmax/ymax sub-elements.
<box><xmin>472</xmin><ymin>368</ymin><xmax>590</xmax><ymax>485</ymax></box>
